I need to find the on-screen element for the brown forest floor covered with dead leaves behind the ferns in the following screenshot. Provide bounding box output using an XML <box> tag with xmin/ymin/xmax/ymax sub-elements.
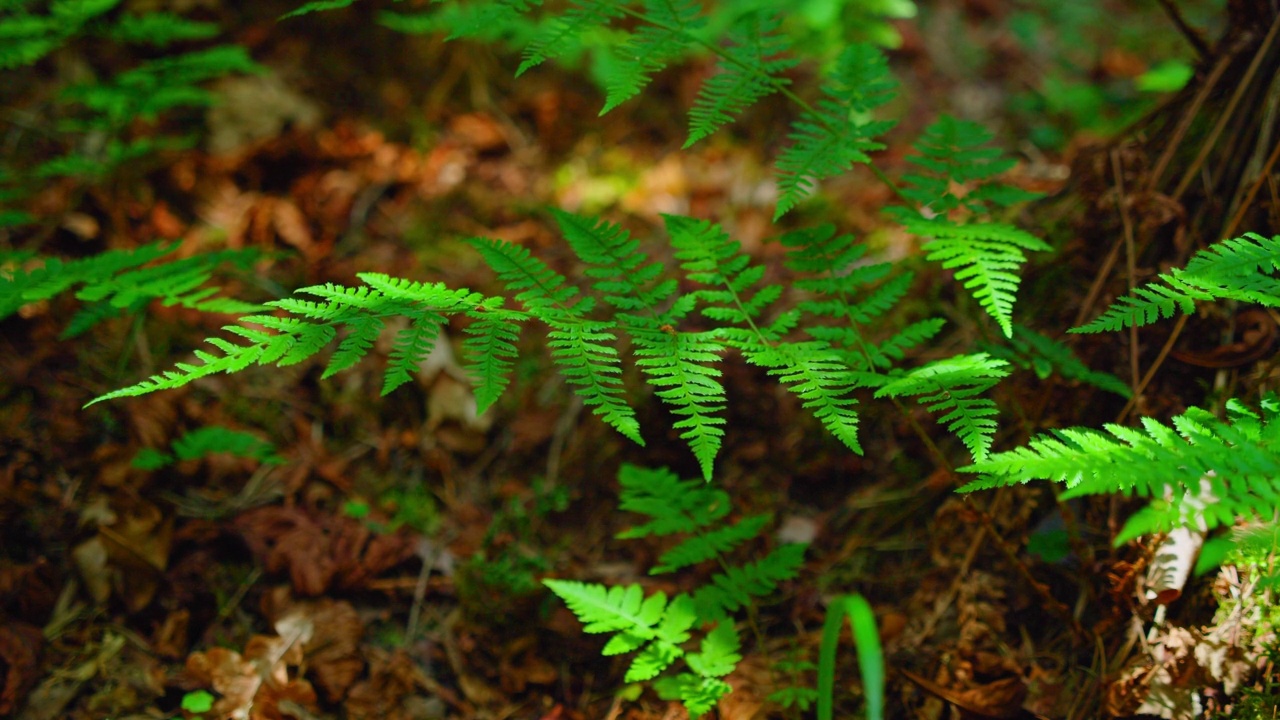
<box><xmin>0</xmin><ymin>0</ymin><xmax>1274</xmax><ymax>720</ymax></box>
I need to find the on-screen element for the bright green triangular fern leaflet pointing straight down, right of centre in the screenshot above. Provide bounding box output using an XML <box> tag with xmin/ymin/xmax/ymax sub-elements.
<box><xmin>904</xmin><ymin>219</ymin><xmax>1051</xmax><ymax>337</ymax></box>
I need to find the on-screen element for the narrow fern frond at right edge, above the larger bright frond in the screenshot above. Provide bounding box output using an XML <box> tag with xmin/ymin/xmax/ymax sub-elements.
<box><xmin>1070</xmin><ymin>233</ymin><xmax>1280</xmax><ymax>333</ymax></box>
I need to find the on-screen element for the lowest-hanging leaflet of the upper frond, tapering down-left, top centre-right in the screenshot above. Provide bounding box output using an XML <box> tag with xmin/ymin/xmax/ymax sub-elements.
<box><xmin>773</xmin><ymin>44</ymin><xmax>897</xmax><ymax>213</ymax></box>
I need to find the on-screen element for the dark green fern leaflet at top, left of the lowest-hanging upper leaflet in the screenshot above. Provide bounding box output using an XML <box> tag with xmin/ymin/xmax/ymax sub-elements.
<box><xmin>685</xmin><ymin>10</ymin><xmax>796</xmax><ymax>149</ymax></box>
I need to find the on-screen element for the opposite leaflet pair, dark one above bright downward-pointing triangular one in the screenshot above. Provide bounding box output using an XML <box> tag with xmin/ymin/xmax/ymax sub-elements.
<box><xmin>891</xmin><ymin>115</ymin><xmax>1050</xmax><ymax>337</ymax></box>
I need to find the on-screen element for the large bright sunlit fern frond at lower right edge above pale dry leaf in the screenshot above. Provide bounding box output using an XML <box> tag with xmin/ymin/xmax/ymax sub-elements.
<box><xmin>960</xmin><ymin>395</ymin><xmax>1280</xmax><ymax>542</ymax></box>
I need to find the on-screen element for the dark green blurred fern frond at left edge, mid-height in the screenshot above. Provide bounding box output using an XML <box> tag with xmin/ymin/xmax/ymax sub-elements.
<box><xmin>0</xmin><ymin>242</ymin><xmax>261</xmax><ymax>338</ymax></box>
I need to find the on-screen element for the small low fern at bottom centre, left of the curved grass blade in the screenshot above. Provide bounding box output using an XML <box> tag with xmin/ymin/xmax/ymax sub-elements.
<box><xmin>543</xmin><ymin>465</ymin><xmax>805</xmax><ymax>717</ymax></box>
